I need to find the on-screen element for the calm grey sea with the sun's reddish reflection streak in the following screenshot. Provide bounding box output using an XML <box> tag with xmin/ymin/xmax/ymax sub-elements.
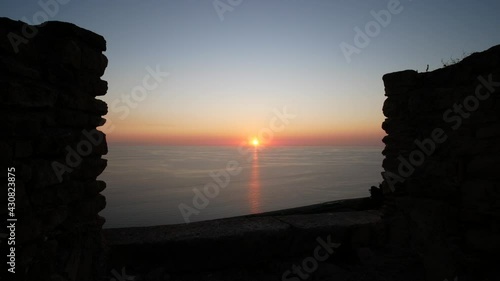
<box><xmin>99</xmin><ymin>146</ymin><xmax>382</xmax><ymax>228</ymax></box>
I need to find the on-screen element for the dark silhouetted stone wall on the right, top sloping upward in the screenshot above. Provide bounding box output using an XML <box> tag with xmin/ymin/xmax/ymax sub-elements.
<box><xmin>382</xmin><ymin>46</ymin><xmax>500</xmax><ymax>281</ymax></box>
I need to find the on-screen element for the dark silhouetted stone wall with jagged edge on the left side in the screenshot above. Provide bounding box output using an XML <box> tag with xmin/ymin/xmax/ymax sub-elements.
<box><xmin>0</xmin><ymin>18</ymin><xmax>107</xmax><ymax>280</ymax></box>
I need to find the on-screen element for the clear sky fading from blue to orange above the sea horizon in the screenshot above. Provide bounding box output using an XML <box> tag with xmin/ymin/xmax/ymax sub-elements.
<box><xmin>0</xmin><ymin>0</ymin><xmax>500</xmax><ymax>145</ymax></box>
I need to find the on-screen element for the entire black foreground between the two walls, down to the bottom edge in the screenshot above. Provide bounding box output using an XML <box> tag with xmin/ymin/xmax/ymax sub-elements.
<box><xmin>104</xmin><ymin>211</ymin><xmax>423</xmax><ymax>280</ymax></box>
